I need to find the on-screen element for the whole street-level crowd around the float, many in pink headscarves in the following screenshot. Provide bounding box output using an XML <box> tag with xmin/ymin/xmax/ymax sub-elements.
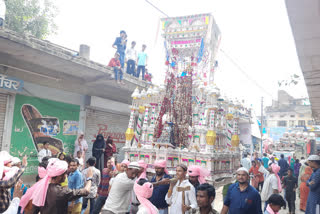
<box><xmin>0</xmin><ymin>137</ymin><xmax>320</xmax><ymax>214</ymax></box>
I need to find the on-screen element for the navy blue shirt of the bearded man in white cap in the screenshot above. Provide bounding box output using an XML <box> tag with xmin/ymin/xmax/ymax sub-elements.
<box><xmin>224</xmin><ymin>183</ymin><xmax>262</xmax><ymax>214</ymax></box>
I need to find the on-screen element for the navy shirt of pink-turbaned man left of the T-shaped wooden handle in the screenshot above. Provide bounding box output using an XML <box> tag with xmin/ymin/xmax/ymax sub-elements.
<box><xmin>149</xmin><ymin>174</ymin><xmax>171</xmax><ymax>209</ymax></box>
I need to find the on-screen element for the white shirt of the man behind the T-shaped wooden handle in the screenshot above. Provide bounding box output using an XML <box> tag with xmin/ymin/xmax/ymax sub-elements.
<box><xmin>166</xmin><ymin>180</ymin><xmax>198</xmax><ymax>214</ymax></box>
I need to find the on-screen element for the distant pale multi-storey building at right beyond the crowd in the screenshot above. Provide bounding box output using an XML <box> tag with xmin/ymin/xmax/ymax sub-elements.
<box><xmin>265</xmin><ymin>90</ymin><xmax>314</xmax><ymax>140</ymax></box>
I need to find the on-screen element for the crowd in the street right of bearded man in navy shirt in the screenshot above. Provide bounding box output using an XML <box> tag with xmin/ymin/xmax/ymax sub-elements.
<box><xmin>241</xmin><ymin>153</ymin><xmax>320</xmax><ymax>214</ymax></box>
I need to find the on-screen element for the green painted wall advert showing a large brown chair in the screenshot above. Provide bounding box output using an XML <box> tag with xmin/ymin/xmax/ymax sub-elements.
<box><xmin>10</xmin><ymin>94</ymin><xmax>80</xmax><ymax>175</ymax></box>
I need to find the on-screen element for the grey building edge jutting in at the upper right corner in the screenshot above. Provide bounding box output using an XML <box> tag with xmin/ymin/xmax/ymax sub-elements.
<box><xmin>286</xmin><ymin>0</ymin><xmax>320</xmax><ymax>123</ymax></box>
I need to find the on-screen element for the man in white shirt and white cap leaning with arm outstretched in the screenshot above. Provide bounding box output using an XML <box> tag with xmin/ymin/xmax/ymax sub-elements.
<box><xmin>102</xmin><ymin>162</ymin><xmax>140</xmax><ymax>214</ymax></box>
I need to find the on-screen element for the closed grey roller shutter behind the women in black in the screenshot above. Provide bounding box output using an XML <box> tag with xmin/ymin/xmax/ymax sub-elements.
<box><xmin>85</xmin><ymin>108</ymin><xmax>129</xmax><ymax>161</ymax></box>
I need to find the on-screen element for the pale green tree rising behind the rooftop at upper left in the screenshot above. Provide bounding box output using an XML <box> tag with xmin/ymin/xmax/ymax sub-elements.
<box><xmin>6</xmin><ymin>0</ymin><xmax>58</xmax><ymax>39</ymax></box>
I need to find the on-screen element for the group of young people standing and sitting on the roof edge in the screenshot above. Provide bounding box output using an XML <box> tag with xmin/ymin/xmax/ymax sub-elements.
<box><xmin>108</xmin><ymin>30</ymin><xmax>152</xmax><ymax>84</ymax></box>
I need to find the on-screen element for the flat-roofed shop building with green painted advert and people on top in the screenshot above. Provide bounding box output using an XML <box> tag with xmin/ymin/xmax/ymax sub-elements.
<box><xmin>0</xmin><ymin>29</ymin><xmax>148</xmax><ymax>175</ymax></box>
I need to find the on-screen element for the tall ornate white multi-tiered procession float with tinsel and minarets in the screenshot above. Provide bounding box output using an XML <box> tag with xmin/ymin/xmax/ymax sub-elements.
<box><xmin>123</xmin><ymin>14</ymin><xmax>251</xmax><ymax>186</ymax></box>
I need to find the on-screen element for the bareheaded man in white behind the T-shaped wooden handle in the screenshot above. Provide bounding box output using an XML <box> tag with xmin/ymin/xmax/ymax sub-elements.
<box><xmin>166</xmin><ymin>164</ymin><xmax>197</xmax><ymax>214</ymax></box>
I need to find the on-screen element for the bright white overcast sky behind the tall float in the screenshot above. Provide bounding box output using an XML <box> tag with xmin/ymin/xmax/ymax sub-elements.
<box><xmin>48</xmin><ymin>0</ymin><xmax>307</xmax><ymax>115</ymax></box>
